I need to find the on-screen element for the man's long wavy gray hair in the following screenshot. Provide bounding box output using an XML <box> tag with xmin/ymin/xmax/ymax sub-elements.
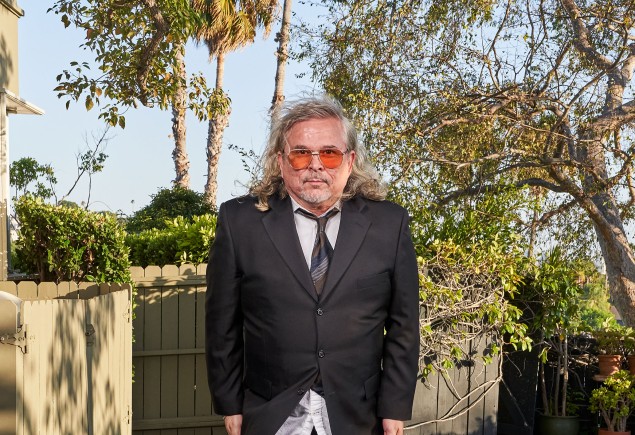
<box><xmin>249</xmin><ymin>96</ymin><xmax>386</xmax><ymax>211</ymax></box>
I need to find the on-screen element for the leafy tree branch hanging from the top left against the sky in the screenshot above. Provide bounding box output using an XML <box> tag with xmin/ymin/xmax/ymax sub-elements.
<box><xmin>49</xmin><ymin>0</ymin><xmax>211</xmax><ymax>128</ymax></box>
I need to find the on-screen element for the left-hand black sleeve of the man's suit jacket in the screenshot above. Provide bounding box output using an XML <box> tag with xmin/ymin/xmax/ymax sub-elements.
<box><xmin>205</xmin><ymin>204</ymin><xmax>244</xmax><ymax>415</ymax></box>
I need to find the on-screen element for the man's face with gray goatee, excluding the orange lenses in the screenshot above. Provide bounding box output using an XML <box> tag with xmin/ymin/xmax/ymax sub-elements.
<box><xmin>278</xmin><ymin>118</ymin><xmax>355</xmax><ymax>216</ymax></box>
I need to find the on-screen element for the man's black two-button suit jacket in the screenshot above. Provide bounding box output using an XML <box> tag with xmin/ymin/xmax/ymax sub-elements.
<box><xmin>205</xmin><ymin>197</ymin><xmax>419</xmax><ymax>435</ymax></box>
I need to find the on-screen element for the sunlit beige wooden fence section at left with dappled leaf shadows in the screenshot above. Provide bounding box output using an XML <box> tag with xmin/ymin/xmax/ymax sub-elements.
<box><xmin>0</xmin><ymin>282</ymin><xmax>132</xmax><ymax>434</ymax></box>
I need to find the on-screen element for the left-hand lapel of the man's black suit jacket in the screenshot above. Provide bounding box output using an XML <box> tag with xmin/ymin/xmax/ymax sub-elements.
<box><xmin>262</xmin><ymin>197</ymin><xmax>316</xmax><ymax>300</ymax></box>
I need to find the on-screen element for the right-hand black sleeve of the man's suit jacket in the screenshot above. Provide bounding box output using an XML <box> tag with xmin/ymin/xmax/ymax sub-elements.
<box><xmin>377</xmin><ymin>212</ymin><xmax>419</xmax><ymax>420</ymax></box>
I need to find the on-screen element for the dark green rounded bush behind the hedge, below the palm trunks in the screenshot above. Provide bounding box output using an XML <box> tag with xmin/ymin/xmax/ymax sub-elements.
<box><xmin>126</xmin><ymin>186</ymin><xmax>210</xmax><ymax>233</ymax></box>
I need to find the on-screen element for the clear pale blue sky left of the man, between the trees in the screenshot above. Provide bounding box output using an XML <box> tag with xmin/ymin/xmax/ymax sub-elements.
<box><xmin>9</xmin><ymin>0</ymin><xmax>314</xmax><ymax>214</ymax></box>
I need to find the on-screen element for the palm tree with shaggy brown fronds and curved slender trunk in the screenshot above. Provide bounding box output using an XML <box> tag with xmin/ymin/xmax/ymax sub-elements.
<box><xmin>193</xmin><ymin>0</ymin><xmax>278</xmax><ymax>206</ymax></box>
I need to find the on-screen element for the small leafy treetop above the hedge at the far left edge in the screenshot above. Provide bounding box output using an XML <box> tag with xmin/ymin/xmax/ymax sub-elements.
<box><xmin>9</xmin><ymin>157</ymin><xmax>57</xmax><ymax>201</ymax></box>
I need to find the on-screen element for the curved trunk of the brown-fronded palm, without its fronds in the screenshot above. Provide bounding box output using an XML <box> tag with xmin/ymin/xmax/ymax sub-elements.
<box><xmin>205</xmin><ymin>54</ymin><xmax>231</xmax><ymax>208</ymax></box>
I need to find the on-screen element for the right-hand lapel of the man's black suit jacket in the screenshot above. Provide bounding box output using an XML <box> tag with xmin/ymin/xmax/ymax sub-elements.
<box><xmin>321</xmin><ymin>198</ymin><xmax>370</xmax><ymax>300</ymax></box>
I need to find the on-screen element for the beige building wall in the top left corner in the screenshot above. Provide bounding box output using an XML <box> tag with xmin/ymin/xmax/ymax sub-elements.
<box><xmin>0</xmin><ymin>0</ymin><xmax>24</xmax><ymax>95</ymax></box>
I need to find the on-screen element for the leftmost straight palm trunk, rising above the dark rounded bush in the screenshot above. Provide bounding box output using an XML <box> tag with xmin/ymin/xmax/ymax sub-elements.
<box><xmin>172</xmin><ymin>46</ymin><xmax>190</xmax><ymax>189</ymax></box>
